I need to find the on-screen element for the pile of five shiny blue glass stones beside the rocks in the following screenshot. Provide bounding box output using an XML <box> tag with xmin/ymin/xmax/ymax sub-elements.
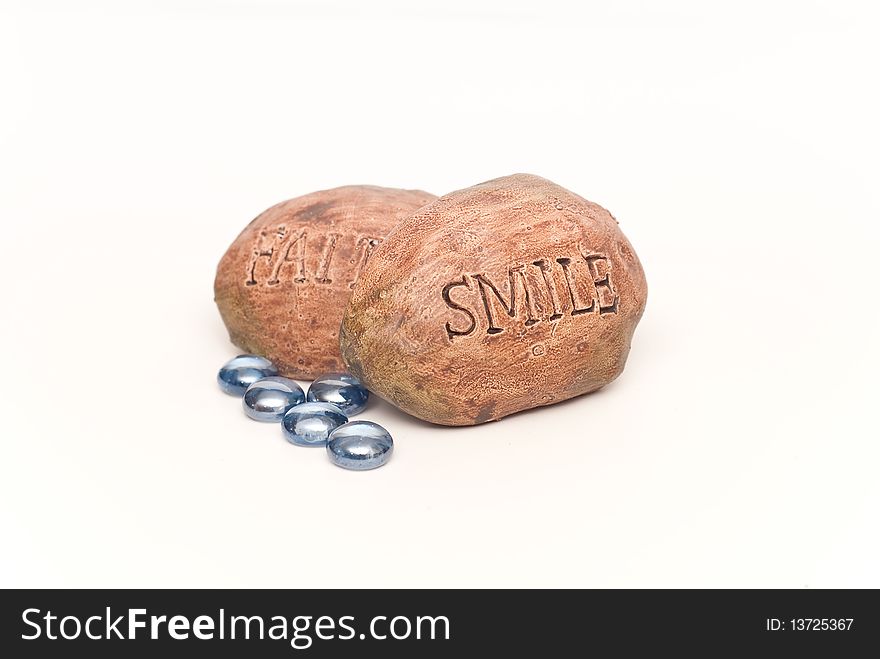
<box><xmin>217</xmin><ymin>355</ymin><xmax>394</xmax><ymax>470</ymax></box>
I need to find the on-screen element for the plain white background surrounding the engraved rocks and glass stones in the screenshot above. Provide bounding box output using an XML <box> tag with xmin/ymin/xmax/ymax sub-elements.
<box><xmin>0</xmin><ymin>0</ymin><xmax>880</xmax><ymax>588</ymax></box>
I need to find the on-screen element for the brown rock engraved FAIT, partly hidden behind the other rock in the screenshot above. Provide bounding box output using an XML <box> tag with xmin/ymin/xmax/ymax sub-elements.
<box><xmin>214</xmin><ymin>185</ymin><xmax>436</xmax><ymax>379</ymax></box>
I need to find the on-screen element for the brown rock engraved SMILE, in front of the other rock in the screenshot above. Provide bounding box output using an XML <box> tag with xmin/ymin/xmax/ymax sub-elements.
<box><xmin>340</xmin><ymin>174</ymin><xmax>647</xmax><ymax>426</ymax></box>
